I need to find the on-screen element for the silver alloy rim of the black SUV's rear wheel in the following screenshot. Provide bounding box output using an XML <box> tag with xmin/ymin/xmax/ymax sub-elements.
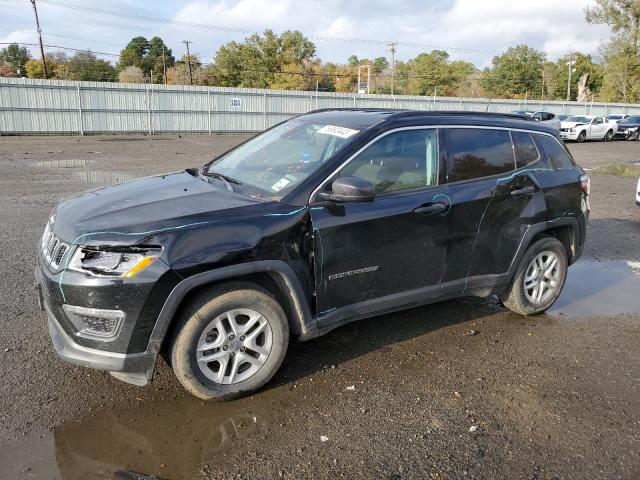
<box><xmin>524</xmin><ymin>250</ymin><xmax>561</xmax><ymax>305</ymax></box>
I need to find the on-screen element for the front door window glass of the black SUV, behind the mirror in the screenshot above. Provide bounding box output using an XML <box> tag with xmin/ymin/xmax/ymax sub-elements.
<box><xmin>339</xmin><ymin>129</ymin><xmax>438</xmax><ymax>193</ymax></box>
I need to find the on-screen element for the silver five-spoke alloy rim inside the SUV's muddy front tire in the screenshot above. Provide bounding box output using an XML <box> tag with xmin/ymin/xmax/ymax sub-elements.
<box><xmin>196</xmin><ymin>308</ymin><xmax>273</xmax><ymax>385</ymax></box>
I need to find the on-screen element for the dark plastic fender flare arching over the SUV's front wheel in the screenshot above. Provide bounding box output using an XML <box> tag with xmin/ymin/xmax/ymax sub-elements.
<box><xmin>146</xmin><ymin>260</ymin><xmax>317</xmax><ymax>376</ymax></box>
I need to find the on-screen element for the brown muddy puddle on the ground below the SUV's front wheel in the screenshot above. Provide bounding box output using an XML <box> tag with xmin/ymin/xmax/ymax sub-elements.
<box><xmin>0</xmin><ymin>398</ymin><xmax>276</xmax><ymax>480</ymax></box>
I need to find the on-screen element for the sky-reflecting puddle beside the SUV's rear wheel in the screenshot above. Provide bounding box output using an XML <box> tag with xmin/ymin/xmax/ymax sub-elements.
<box><xmin>547</xmin><ymin>260</ymin><xmax>640</xmax><ymax>318</ymax></box>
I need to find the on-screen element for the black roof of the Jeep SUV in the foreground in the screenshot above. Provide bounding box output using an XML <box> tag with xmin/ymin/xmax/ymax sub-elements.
<box><xmin>306</xmin><ymin>108</ymin><xmax>557</xmax><ymax>134</ymax></box>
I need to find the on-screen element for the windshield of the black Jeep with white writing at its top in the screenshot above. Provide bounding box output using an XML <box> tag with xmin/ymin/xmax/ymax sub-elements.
<box><xmin>208</xmin><ymin>117</ymin><xmax>360</xmax><ymax>200</ymax></box>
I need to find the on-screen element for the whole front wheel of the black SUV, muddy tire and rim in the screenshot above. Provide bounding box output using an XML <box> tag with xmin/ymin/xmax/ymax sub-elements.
<box><xmin>170</xmin><ymin>282</ymin><xmax>289</xmax><ymax>400</ymax></box>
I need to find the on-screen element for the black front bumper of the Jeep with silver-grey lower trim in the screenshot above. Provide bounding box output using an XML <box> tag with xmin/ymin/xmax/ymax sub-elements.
<box><xmin>35</xmin><ymin>249</ymin><xmax>174</xmax><ymax>385</ymax></box>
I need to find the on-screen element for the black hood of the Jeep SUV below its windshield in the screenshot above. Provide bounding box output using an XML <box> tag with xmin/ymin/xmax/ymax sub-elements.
<box><xmin>54</xmin><ymin>171</ymin><xmax>268</xmax><ymax>244</ymax></box>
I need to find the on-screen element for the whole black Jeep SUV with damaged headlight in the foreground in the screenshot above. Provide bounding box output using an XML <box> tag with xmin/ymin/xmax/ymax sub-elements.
<box><xmin>36</xmin><ymin>110</ymin><xmax>589</xmax><ymax>399</ymax></box>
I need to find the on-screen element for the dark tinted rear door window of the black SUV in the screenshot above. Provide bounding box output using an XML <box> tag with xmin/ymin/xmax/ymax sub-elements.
<box><xmin>444</xmin><ymin>128</ymin><xmax>515</xmax><ymax>182</ymax></box>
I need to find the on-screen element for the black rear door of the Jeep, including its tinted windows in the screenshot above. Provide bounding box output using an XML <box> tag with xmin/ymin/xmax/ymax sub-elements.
<box><xmin>443</xmin><ymin>128</ymin><xmax>544</xmax><ymax>293</ymax></box>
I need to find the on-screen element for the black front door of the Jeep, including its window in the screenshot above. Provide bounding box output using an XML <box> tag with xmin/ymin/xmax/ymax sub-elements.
<box><xmin>311</xmin><ymin>129</ymin><xmax>450</xmax><ymax>315</ymax></box>
